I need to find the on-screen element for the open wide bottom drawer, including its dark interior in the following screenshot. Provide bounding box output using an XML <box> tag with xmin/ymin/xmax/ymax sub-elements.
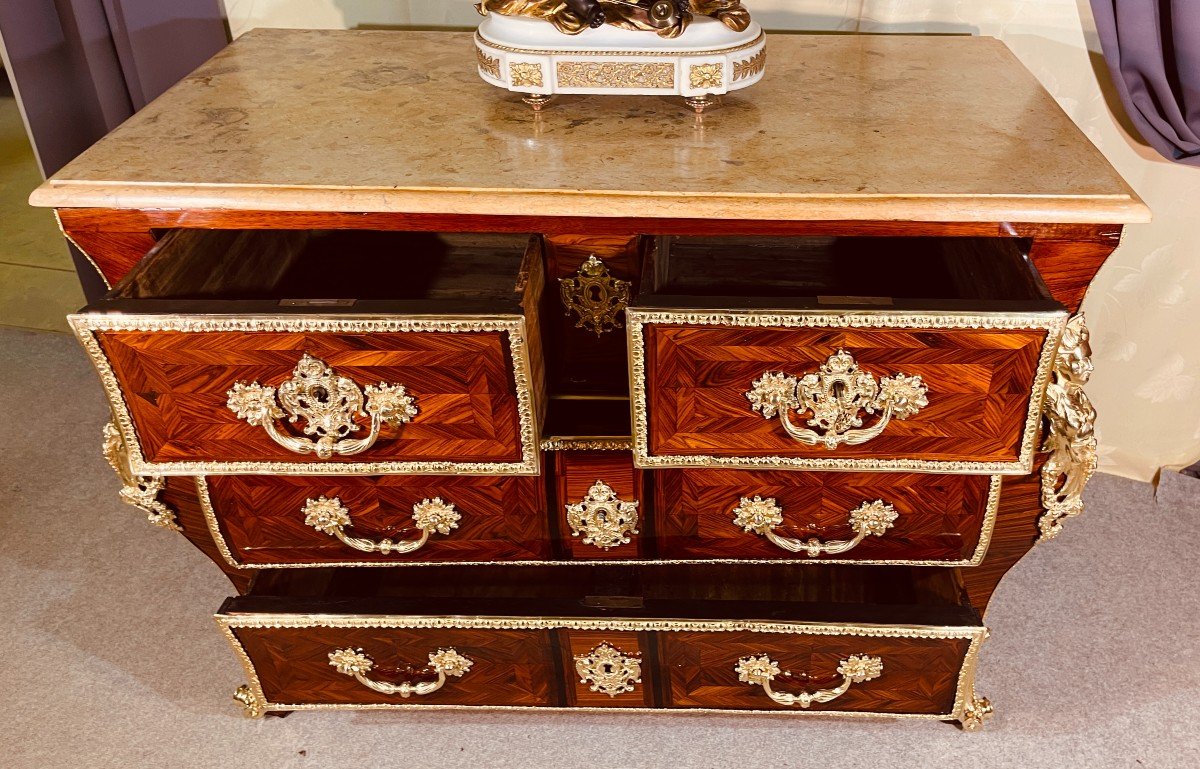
<box><xmin>217</xmin><ymin>565</ymin><xmax>986</xmax><ymax>722</ymax></box>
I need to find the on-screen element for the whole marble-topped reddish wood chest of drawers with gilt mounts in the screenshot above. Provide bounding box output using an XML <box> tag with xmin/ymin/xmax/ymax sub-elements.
<box><xmin>34</xmin><ymin>26</ymin><xmax>1147</xmax><ymax>728</ymax></box>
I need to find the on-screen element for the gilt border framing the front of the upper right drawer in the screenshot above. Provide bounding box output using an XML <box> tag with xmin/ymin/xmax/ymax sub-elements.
<box><xmin>625</xmin><ymin>307</ymin><xmax>1067</xmax><ymax>475</ymax></box>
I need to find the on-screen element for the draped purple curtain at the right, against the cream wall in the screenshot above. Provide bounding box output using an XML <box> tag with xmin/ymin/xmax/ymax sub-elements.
<box><xmin>1092</xmin><ymin>0</ymin><xmax>1200</xmax><ymax>166</ymax></box>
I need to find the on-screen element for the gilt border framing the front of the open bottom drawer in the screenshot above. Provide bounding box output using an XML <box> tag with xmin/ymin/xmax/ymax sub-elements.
<box><xmin>214</xmin><ymin>614</ymin><xmax>990</xmax><ymax>731</ymax></box>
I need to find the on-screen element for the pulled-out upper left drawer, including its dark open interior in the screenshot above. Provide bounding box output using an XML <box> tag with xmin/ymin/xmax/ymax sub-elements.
<box><xmin>70</xmin><ymin>230</ymin><xmax>544</xmax><ymax>475</ymax></box>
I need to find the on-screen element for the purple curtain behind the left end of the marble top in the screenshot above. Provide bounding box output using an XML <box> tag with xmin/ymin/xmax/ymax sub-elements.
<box><xmin>0</xmin><ymin>0</ymin><xmax>228</xmax><ymax>301</ymax></box>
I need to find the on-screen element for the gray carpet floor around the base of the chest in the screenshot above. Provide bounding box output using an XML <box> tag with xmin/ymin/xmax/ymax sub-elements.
<box><xmin>0</xmin><ymin>330</ymin><xmax>1200</xmax><ymax>769</ymax></box>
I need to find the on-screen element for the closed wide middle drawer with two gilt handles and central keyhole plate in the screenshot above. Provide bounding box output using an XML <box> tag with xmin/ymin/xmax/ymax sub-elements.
<box><xmin>196</xmin><ymin>458</ymin><xmax>1002</xmax><ymax>569</ymax></box>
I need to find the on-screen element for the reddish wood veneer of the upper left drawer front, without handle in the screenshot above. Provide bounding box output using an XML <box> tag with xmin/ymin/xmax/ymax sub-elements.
<box><xmin>98</xmin><ymin>331</ymin><xmax>521</xmax><ymax>464</ymax></box>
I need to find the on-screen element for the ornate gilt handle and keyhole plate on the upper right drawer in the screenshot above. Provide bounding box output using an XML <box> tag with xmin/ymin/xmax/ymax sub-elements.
<box><xmin>745</xmin><ymin>350</ymin><xmax>929</xmax><ymax>450</ymax></box>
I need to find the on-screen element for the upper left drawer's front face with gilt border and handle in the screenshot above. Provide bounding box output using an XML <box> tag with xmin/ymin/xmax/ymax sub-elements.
<box><xmin>71</xmin><ymin>314</ymin><xmax>539</xmax><ymax>475</ymax></box>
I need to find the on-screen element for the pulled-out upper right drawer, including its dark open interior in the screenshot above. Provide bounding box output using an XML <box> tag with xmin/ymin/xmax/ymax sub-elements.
<box><xmin>628</xmin><ymin>238</ymin><xmax>1067</xmax><ymax>474</ymax></box>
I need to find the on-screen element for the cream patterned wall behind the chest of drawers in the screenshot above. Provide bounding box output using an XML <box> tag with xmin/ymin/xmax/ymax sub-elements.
<box><xmin>226</xmin><ymin>0</ymin><xmax>1200</xmax><ymax>480</ymax></box>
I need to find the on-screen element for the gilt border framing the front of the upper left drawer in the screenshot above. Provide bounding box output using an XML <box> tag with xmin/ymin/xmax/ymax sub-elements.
<box><xmin>67</xmin><ymin>313</ymin><xmax>541</xmax><ymax>475</ymax></box>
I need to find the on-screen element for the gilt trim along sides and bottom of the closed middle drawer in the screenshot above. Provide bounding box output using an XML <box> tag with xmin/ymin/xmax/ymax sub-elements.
<box><xmin>196</xmin><ymin>475</ymin><xmax>1003</xmax><ymax>571</ymax></box>
